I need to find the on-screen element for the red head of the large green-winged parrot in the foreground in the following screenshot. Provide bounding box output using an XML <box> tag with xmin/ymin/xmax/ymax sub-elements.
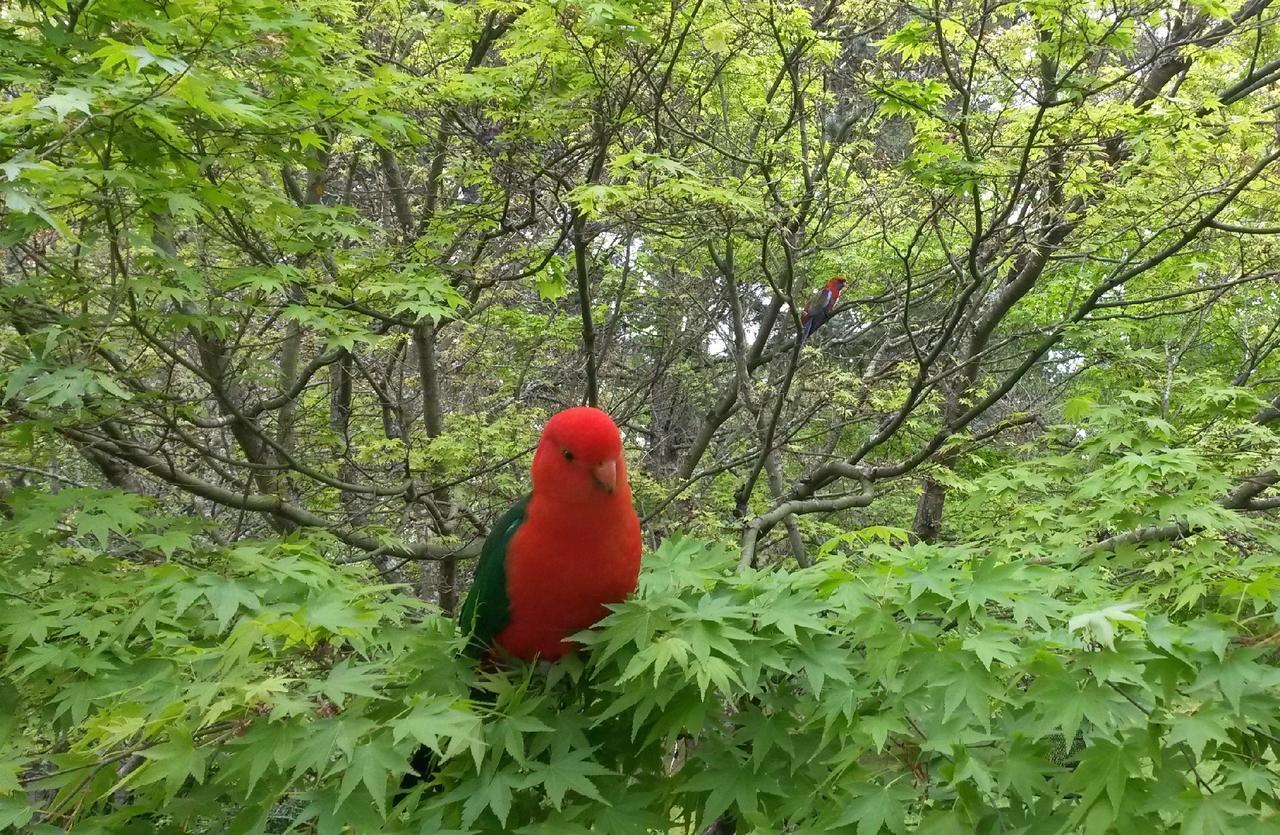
<box><xmin>534</xmin><ymin>406</ymin><xmax>631</xmax><ymax>502</ymax></box>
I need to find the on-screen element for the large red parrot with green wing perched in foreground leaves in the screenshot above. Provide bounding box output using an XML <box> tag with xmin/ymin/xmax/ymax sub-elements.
<box><xmin>458</xmin><ymin>406</ymin><xmax>641</xmax><ymax>661</ymax></box>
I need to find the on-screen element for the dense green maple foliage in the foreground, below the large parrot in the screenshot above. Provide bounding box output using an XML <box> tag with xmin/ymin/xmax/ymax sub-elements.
<box><xmin>0</xmin><ymin>392</ymin><xmax>1280</xmax><ymax>834</ymax></box>
